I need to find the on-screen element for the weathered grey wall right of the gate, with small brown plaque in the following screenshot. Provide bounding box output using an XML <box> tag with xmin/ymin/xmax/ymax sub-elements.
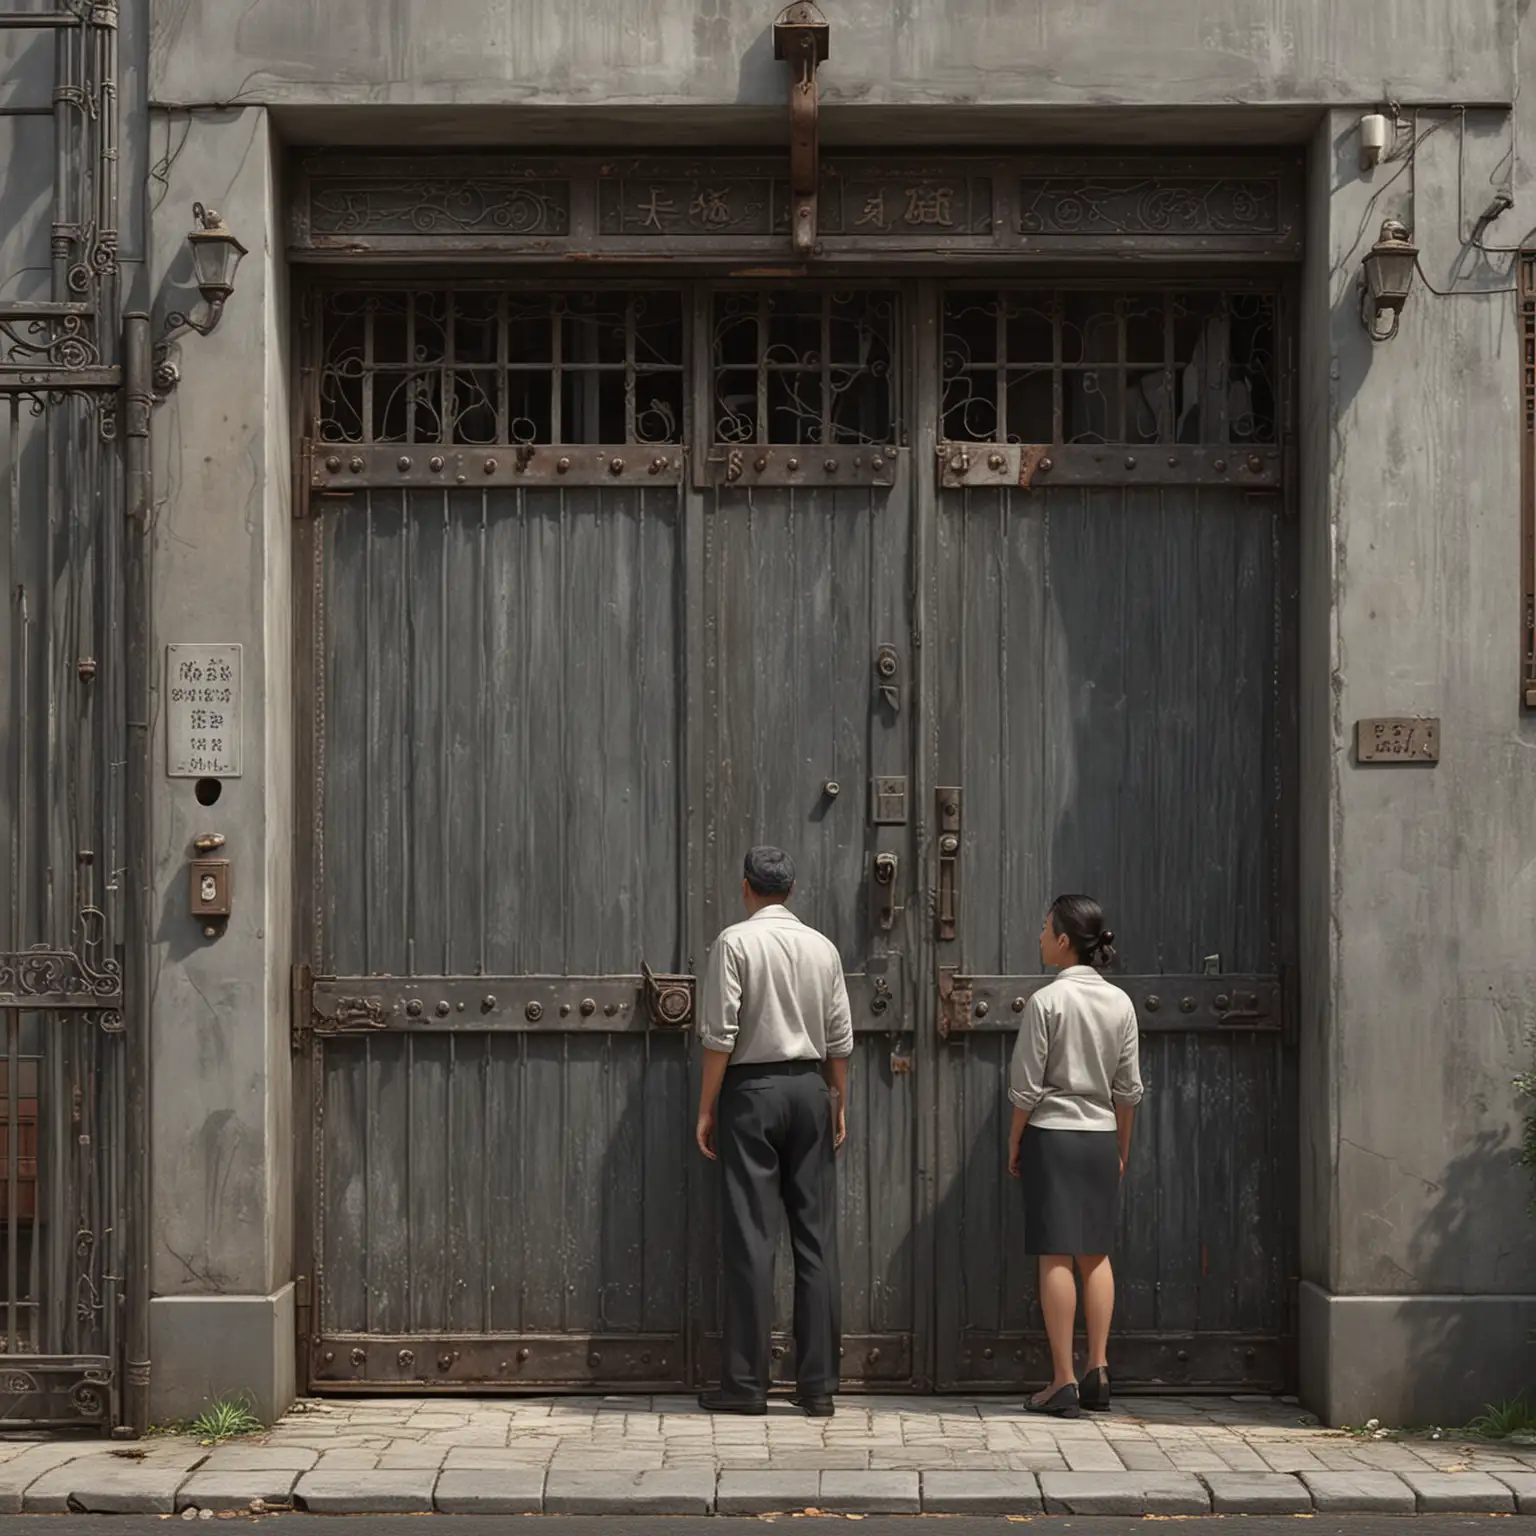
<box><xmin>1303</xmin><ymin>112</ymin><xmax>1536</xmax><ymax>1422</ymax></box>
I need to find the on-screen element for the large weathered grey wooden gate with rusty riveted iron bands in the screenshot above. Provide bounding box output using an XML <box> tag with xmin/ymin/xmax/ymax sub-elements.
<box><xmin>295</xmin><ymin>152</ymin><xmax>1295</xmax><ymax>1392</ymax></box>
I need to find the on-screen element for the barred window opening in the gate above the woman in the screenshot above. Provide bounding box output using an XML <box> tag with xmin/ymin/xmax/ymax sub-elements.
<box><xmin>943</xmin><ymin>289</ymin><xmax>1281</xmax><ymax>447</ymax></box>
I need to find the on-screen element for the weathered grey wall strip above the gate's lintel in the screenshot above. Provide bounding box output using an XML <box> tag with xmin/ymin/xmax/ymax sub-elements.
<box><xmin>152</xmin><ymin>0</ymin><xmax>1516</xmax><ymax>108</ymax></box>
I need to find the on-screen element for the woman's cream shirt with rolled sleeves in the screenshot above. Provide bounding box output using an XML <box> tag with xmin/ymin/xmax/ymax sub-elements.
<box><xmin>1008</xmin><ymin>965</ymin><xmax>1141</xmax><ymax>1130</ymax></box>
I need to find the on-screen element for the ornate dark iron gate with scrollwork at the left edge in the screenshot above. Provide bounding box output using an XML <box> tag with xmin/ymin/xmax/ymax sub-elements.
<box><xmin>0</xmin><ymin>0</ymin><xmax>139</xmax><ymax>1427</ymax></box>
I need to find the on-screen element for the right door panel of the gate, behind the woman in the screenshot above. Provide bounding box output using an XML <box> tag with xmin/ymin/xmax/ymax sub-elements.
<box><xmin>934</xmin><ymin>289</ymin><xmax>1292</xmax><ymax>1387</ymax></box>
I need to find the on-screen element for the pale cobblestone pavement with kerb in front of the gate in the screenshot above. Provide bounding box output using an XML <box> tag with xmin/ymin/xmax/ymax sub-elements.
<box><xmin>0</xmin><ymin>1398</ymin><xmax>1536</xmax><ymax>1514</ymax></box>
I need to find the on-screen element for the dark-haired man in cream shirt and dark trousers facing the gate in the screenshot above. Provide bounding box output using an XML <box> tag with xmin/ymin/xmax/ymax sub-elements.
<box><xmin>699</xmin><ymin>848</ymin><xmax>854</xmax><ymax>1418</ymax></box>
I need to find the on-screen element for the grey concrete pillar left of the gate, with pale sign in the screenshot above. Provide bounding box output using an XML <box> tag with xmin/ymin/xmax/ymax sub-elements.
<box><xmin>152</xmin><ymin>108</ymin><xmax>293</xmax><ymax>1418</ymax></box>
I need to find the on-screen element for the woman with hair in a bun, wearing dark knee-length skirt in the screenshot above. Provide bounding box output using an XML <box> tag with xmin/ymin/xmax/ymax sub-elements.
<box><xmin>1008</xmin><ymin>895</ymin><xmax>1141</xmax><ymax>1419</ymax></box>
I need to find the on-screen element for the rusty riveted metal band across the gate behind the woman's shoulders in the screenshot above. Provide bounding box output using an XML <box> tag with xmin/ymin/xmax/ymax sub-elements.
<box><xmin>943</xmin><ymin>974</ymin><xmax>1283</xmax><ymax>1035</ymax></box>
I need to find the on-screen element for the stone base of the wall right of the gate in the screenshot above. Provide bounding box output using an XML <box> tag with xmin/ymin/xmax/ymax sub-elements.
<box><xmin>1299</xmin><ymin>1283</ymin><xmax>1536</xmax><ymax>1427</ymax></box>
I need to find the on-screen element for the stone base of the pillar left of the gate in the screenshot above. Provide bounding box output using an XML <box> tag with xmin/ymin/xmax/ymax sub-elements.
<box><xmin>149</xmin><ymin>1284</ymin><xmax>295</xmax><ymax>1424</ymax></box>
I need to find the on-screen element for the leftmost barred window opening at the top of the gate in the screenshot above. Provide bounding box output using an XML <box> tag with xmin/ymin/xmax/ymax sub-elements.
<box><xmin>315</xmin><ymin>287</ymin><xmax>684</xmax><ymax>447</ymax></box>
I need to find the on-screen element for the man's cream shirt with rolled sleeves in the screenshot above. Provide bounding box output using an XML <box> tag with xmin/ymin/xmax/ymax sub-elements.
<box><xmin>699</xmin><ymin>902</ymin><xmax>854</xmax><ymax>1064</ymax></box>
